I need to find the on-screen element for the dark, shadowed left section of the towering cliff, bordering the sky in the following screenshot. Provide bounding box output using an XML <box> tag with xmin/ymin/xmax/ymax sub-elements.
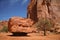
<box><xmin>27</xmin><ymin>0</ymin><xmax>37</xmax><ymax>22</ymax></box>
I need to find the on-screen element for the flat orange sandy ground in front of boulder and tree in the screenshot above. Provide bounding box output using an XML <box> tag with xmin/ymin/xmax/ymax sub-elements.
<box><xmin>0</xmin><ymin>33</ymin><xmax>60</xmax><ymax>40</ymax></box>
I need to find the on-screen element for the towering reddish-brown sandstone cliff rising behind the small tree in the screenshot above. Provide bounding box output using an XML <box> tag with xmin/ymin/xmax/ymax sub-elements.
<box><xmin>27</xmin><ymin>0</ymin><xmax>60</xmax><ymax>32</ymax></box>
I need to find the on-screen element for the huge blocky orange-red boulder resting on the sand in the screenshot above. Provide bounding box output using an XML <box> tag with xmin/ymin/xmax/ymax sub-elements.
<box><xmin>8</xmin><ymin>17</ymin><xmax>33</xmax><ymax>33</ymax></box>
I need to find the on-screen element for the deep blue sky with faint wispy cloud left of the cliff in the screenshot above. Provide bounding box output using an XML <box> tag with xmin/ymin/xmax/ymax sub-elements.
<box><xmin>0</xmin><ymin>0</ymin><xmax>29</xmax><ymax>20</ymax></box>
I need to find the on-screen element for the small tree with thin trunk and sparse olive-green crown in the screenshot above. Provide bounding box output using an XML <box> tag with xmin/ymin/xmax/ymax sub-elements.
<box><xmin>35</xmin><ymin>19</ymin><xmax>52</xmax><ymax>36</ymax></box>
